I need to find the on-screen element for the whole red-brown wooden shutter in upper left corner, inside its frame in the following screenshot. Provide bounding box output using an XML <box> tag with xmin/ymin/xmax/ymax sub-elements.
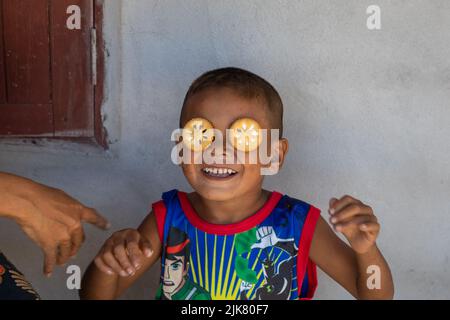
<box><xmin>0</xmin><ymin>0</ymin><xmax>94</xmax><ymax>137</ymax></box>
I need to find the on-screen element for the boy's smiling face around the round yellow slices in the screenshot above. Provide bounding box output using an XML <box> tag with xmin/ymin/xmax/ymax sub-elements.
<box><xmin>181</xmin><ymin>88</ymin><xmax>287</xmax><ymax>201</ymax></box>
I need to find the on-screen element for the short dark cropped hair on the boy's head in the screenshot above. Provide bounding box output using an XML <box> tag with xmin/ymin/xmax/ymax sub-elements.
<box><xmin>180</xmin><ymin>67</ymin><xmax>283</xmax><ymax>138</ymax></box>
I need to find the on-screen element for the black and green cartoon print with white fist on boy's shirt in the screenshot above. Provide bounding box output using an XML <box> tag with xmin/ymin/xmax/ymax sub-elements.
<box><xmin>235</xmin><ymin>226</ymin><xmax>297</xmax><ymax>300</ymax></box>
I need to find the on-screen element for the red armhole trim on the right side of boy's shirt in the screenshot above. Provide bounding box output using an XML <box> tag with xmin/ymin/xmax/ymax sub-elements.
<box><xmin>297</xmin><ymin>205</ymin><xmax>320</xmax><ymax>300</ymax></box>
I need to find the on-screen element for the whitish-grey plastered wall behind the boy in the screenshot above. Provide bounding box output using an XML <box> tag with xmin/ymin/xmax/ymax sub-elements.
<box><xmin>0</xmin><ymin>0</ymin><xmax>450</xmax><ymax>299</ymax></box>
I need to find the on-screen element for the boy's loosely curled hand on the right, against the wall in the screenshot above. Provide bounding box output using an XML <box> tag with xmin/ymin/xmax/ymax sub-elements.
<box><xmin>328</xmin><ymin>195</ymin><xmax>380</xmax><ymax>254</ymax></box>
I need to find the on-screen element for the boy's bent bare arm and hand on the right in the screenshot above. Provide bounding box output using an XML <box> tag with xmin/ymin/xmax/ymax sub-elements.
<box><xmin>310</xmin><ymin>196</ymin><xmax>394</xmax><ymax>299</ymax></box>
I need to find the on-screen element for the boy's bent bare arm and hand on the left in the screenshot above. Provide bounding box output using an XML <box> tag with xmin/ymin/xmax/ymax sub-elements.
<box><xmin>79</xmin><ymin>211</ymin><xmax>161</xmax><ymax>300</ymax></box>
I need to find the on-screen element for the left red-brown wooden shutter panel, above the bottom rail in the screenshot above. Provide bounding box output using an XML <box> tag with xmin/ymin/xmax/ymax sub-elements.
<box><xmin>2</xmin><ymin>0</ymin><xmax>51</xmax><ymax>104</ymax></box>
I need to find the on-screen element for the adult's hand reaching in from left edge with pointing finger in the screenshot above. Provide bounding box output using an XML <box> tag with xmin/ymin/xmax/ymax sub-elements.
<box><xmin>0</xmin><ymin>173</ymin><xmax>109</xmax><ymax>276</ymax></box>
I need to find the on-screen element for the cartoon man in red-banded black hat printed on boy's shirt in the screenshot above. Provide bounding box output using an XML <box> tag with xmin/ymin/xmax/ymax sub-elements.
<box><xmin>156</xmin><ymin>227</ymin><xmax>211</xmax><ymax>300</ymax></box>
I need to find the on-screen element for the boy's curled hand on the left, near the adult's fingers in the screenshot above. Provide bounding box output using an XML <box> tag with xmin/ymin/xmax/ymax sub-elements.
<box><xmin>94</xmin><ymin>229</ymin><xmax>153</xmax><ymax>277</ymax></box>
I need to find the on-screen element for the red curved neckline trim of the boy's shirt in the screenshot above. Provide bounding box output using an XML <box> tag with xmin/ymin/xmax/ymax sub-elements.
<box><xmin>178</xmin><ymin>191</ymin><xmax>282</xmax><ymax>235</ymax></box>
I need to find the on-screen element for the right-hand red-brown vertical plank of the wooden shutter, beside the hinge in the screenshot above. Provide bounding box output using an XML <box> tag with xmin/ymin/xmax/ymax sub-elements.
<box><xmin>50</xmin><ymin>0</ymin><xmax>94</xmax><ymax>137</ymax></box>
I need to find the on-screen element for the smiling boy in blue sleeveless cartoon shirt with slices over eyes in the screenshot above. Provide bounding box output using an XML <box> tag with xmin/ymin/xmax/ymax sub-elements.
<box><xmin>80</xmin><ymin>68</ymin><xmax>394</xmax><ymax>300</ymax></box>
